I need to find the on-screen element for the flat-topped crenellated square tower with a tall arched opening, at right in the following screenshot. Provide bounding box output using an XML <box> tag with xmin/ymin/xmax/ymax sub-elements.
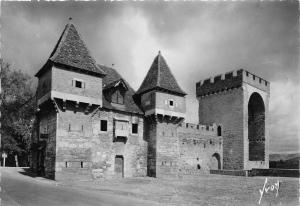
<box><xmin>196</xmin><ymin>69</ymin><xmax>270</xmax><ymax>170</ymax></box>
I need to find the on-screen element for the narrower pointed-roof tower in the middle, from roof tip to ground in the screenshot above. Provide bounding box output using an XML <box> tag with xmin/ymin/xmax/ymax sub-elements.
<box><xmin>136</xmin><ymin>52</ymin><xmax>186</xmax><ymax>177</ymax></box>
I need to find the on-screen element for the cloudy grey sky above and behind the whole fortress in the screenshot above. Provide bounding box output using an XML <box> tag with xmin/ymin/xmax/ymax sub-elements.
<box><xmin>1</xmin><ymin>1</ymin><xmax>300</xmax><ymax>153</ymax></box>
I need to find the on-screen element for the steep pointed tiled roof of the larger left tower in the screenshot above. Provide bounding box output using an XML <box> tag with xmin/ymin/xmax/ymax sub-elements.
<box><xmin>36</xmin><ymin>19</ymin><xmax>105</xmax><ymax>76</ymax></box>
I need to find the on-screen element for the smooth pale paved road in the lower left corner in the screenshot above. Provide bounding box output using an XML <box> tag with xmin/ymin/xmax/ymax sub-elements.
<box><xmin>0</xmin><ymin>168</ymin><xmax>162</xmax><ymax>206</ymax></box>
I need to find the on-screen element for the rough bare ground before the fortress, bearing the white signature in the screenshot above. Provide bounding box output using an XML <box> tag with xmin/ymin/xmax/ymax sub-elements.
<box><xmin>60</xmin><ymin>175</ymin><xmax>300</xmax><ymax>206</ymax></box>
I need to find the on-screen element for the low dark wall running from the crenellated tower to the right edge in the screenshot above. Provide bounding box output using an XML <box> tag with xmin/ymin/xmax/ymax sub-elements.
<box><xmin>249</xmin><ymin>169</ymin><xmax>300</xmax><ymax>178</ymax></box>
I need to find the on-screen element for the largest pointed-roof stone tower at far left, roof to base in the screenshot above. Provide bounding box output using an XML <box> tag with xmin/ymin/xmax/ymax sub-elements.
<box><xmin>35</xmin><ymin>19</ymin><xmax>105</xmax><ymax>178</ymax></box>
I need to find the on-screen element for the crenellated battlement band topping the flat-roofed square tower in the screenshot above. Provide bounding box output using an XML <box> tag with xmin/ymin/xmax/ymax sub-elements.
<box><xmin>196</xmin><ymin>69</ymin><xmax>270</xmax><ymax>97</ymax></box>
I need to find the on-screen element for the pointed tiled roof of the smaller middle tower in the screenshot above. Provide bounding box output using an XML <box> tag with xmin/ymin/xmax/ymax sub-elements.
<box><xmin>136</xmin><ymin>51</ymin><xmax>186</xmax><ymax>96</ymax></box>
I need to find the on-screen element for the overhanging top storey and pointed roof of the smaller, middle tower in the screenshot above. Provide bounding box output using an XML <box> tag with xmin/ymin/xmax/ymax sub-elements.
<box><xmin>136</xmin><ymin>52</ymin><xmax>186</xmax><ymax>120</ymax></box>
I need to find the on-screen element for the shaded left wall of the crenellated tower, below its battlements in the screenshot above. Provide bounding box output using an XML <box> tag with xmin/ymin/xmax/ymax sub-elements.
<box><xmin>198</xmin><ymin>87</ymin><xmax>244</xmax><ymax>170</ymax></box>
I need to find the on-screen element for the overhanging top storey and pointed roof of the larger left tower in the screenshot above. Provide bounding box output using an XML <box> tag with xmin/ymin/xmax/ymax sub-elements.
<box><xmin>35</xmin><ymin>18</ymin><xmax>105</xmax><ymax>110</ymax></box>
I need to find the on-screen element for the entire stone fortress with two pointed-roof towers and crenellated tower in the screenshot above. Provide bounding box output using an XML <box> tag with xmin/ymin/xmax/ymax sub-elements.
<box><xmin>31</xmin><ymin>22</ymin><xmax>270</xmax><ymax>179</ymax></box>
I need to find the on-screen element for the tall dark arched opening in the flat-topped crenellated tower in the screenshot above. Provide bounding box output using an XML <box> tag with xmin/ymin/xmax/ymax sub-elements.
<box><xmin>248</xmin><ymin>92</ymin><xmax>265</xmax><ymax>161</ymax></box>
